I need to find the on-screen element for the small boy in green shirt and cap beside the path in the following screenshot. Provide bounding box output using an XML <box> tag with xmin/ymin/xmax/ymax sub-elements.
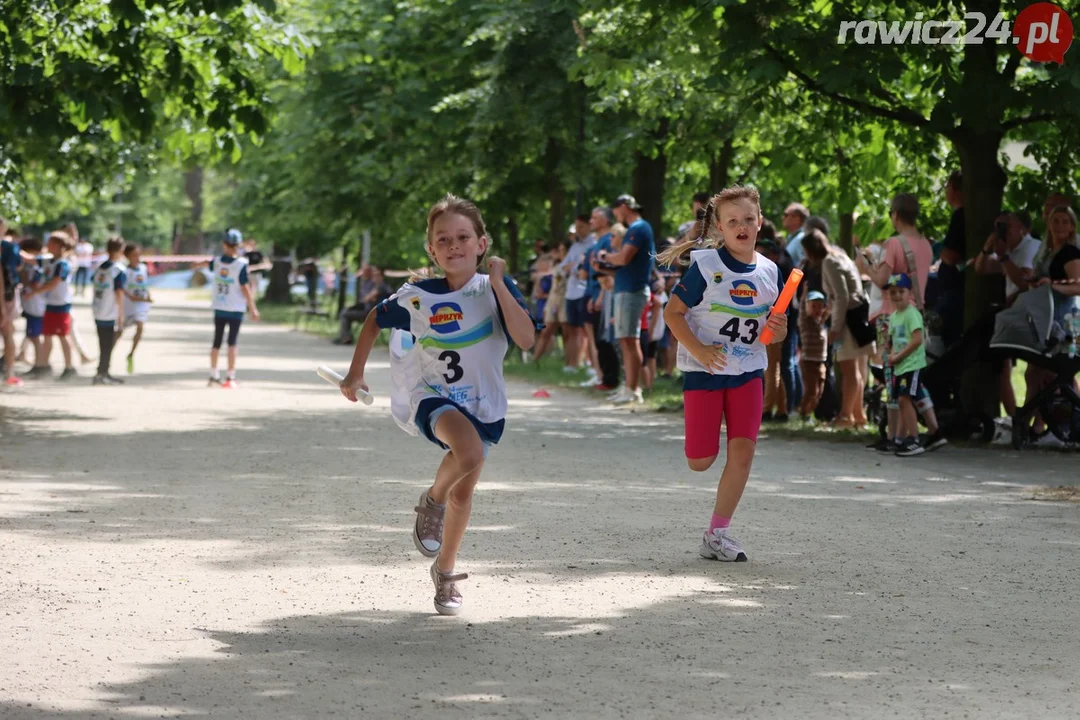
<box><xmin>886</xmin><ymin>273</ymin><xmax>927</xmax><ymax>458</ymax></box>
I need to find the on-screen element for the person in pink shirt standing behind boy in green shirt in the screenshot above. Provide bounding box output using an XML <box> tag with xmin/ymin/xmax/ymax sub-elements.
<box><xmin>856</xmin><ymin>192</ymin><xmax>946</xmax><ymax>453</ymax></box>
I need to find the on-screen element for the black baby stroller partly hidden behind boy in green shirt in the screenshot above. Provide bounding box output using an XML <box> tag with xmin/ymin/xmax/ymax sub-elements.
<box><xmin>863</xmin><ymin>305</ymin><xmax>999</xmax><ymax>443</ymax></box>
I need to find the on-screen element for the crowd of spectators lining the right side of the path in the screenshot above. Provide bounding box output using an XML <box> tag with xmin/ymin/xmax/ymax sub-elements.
<box><xmin>511</xmin><ymin>180</ymin><xmax>1080</xmax><ymax>449</ymax></box>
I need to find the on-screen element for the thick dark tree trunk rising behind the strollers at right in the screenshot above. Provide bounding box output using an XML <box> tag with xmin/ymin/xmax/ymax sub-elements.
<box><xmin>955</xmin><ymin>127</ymin><xmax>1005</xmax><ymax>418</ymax></box>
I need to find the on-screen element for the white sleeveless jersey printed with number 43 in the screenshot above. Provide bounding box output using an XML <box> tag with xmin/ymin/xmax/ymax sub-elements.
<box><xmin>677</xmin><ymin>248</ymin><xmax>780</xmax><ymax>375</ymax></box>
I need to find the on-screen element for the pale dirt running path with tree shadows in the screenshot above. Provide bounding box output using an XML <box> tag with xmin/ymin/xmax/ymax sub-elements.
<box><xmin>0</xmin><ymin>293</ymin><xmax>1080</xmax><ymax>720</ymax></box>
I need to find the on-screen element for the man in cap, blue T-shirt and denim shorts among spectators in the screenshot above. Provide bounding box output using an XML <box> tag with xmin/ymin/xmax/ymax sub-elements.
<box><xmin>597</xmin><ymin>195</ymin><xmax>656</xmax><ymax>405</ymax></box>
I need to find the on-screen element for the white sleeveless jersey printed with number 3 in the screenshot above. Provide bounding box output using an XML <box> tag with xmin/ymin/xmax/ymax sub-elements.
<box><xmin>390</xmin><ymin>274</ymin><xmax>509</xmax><ymax>435</ymax></box>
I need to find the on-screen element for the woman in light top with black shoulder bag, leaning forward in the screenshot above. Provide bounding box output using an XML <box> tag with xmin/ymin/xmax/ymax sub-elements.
<box><xmin>802</xmin><ymin>230</ymin><xmax>874</xmax><ymax>430</ymax></box>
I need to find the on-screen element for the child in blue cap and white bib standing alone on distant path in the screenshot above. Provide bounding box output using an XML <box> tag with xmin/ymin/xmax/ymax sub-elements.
<box><xmin>195</xmin><ymin>229</ymin><xmax>259</xmax><ymax>390</ymax></box>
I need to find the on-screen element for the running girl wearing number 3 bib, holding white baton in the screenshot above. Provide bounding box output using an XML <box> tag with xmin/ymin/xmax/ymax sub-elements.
<box><xmin>341</xmin><ymin>194</ymin><xmax>537</xmax><ymax>615</ymax></box>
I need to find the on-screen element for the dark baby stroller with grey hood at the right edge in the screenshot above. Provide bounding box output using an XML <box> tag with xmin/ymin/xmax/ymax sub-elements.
<box><xmin>990</xmin><ymin>285</ymin><xmax>1080</xmax><ymax>450</ymax></box>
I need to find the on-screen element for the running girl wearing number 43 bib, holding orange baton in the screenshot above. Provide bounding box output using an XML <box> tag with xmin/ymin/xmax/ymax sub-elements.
<box><xmin>658</xmin><ymin>186</ymin><xmax>787</xmax><ymax>562</ymax></box>
